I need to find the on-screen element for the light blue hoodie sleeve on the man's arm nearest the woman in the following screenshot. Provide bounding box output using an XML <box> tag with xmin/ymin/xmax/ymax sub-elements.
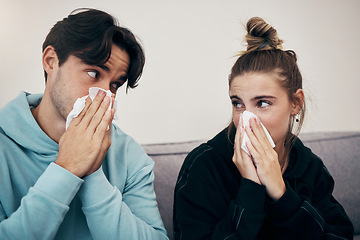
<box><xmin>79</xmin><ymin>141</ymin><xmax>168</xmax><ymax>240</ymax></box>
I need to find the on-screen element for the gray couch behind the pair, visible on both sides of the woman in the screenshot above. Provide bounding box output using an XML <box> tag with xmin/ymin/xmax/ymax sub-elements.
<box><xmin>143</xmin><ymin>132</ymin><xmax>360</xmax><ymax>240</ymax></box>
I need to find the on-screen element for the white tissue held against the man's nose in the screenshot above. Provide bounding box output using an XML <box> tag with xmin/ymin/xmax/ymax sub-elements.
<box><xmin>65</xmin><ymin>87</ymin><xmax>112</xmax><ymax>129</ymax></box>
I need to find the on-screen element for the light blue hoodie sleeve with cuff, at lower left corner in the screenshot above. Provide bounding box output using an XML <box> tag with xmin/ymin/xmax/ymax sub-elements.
<box><xmin>0</xmin><ymin>163</ymin><xmax>83</xmax><ymax>240</ymax></box>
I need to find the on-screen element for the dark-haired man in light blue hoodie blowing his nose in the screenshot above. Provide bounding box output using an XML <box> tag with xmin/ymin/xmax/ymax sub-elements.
<box><xmin>0</xmin><ymin>9</ymin><xmax>167</xmax><ymax>240</ymax></box>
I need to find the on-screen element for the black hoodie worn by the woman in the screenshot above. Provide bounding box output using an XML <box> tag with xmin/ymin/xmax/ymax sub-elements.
<box><xmin>174</xmin><ymin>129</ymin><xmax>354</xmax><ymax>240</ymax></box>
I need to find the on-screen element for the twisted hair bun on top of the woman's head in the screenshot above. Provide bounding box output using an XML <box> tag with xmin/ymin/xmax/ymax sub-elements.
<box><xmin>245</xmin><ymin>17</ymin><xmax>283</xmax><ymax>52</ymax></box>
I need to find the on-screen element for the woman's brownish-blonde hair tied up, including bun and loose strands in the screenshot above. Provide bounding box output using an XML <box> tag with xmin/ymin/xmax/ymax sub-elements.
<box><xmin>228</xmin><ymin>17</ymin><xmax>305</xmax><ymax>150</ymax></box>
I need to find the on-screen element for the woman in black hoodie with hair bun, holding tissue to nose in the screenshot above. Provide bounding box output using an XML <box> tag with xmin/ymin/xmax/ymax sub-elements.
<box><xmin>174</xmin><ymin>17</ymin><xmax>354</xmax><ymax>240</ymax></box>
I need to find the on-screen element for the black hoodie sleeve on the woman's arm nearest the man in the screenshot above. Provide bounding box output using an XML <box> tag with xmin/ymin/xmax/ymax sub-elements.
<box><xmin>174</xmin><ymin>147</ymin><xmax>265</xmax><ymax>240</ymax></box>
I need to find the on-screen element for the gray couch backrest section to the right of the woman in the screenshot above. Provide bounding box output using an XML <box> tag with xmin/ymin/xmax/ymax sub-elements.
<box><xmin>300</xmin><ymin>132</ymin><xmax>360</xmax><ymax>235</ymax></box>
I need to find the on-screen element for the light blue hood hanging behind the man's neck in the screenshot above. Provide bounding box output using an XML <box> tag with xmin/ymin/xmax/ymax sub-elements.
<box><xmin>0</xmin><ymin>92</ymin><xmax>59</xmax><ymax>155</ymax></box>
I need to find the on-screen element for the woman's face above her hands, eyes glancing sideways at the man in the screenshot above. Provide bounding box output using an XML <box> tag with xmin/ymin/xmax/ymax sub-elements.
<box><xmin>230</xmin><ymin>72</ymin><xmax>302</xmax><ymax>150</ymax></box>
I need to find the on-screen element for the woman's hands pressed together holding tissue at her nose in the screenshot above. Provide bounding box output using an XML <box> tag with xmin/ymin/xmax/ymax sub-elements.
<box><xmin>233</xmin><ymin>115</ymin><xmax>286</xmax><ymax>200</ymax></box>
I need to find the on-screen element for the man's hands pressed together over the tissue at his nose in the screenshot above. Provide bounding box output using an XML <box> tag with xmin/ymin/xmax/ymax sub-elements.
<box><xmin>55</xmin><ymin>91</ymin><xmax>115</xmax><ymax>177</ymax></box>
